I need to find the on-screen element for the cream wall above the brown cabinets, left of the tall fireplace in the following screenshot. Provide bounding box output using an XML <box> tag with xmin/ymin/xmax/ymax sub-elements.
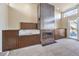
<box><xmin>8</xmin><ymin>3</ymin><xmax>37</xmax><ymax>29</ymax></box>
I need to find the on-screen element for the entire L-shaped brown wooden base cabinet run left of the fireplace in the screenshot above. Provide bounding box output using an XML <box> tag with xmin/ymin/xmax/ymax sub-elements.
<box><xmin>2</xmin><ymin>30</ymin><xmax>40</xmax><ymax>51</ymax></box>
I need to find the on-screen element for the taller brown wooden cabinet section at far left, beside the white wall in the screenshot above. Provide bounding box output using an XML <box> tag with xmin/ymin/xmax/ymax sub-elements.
<box><xmin>2</xmin><ymin>30</ymin><xmax>18</xmax><ymax>51</ymax></box>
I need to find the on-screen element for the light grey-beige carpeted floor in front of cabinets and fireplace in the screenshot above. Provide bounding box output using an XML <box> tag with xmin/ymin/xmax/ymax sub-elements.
<box><xmin>0</xmin><ymin>39</ymin><xmax>79</xmax><ymax>56</ymax></box>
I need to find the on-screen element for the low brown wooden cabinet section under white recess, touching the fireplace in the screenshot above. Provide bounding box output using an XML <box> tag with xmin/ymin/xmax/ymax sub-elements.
<box><xmin>18</xmin><ymin>35</ymin><xmax>40</xmax><ymax>48</ymax></box>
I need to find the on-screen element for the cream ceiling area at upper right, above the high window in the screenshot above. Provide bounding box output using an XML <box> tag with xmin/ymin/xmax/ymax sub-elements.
<box><xmin>51</xmin><ymin>3</ymin><xmax>78</xmax><ymax>12</ymax></box>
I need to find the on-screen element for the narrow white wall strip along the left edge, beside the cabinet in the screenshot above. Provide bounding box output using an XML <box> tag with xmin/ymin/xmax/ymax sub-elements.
<box><xmin>0</xmin><ymin>3</ymin><xmax>8</xmax><ymax>52</ymax></box>
